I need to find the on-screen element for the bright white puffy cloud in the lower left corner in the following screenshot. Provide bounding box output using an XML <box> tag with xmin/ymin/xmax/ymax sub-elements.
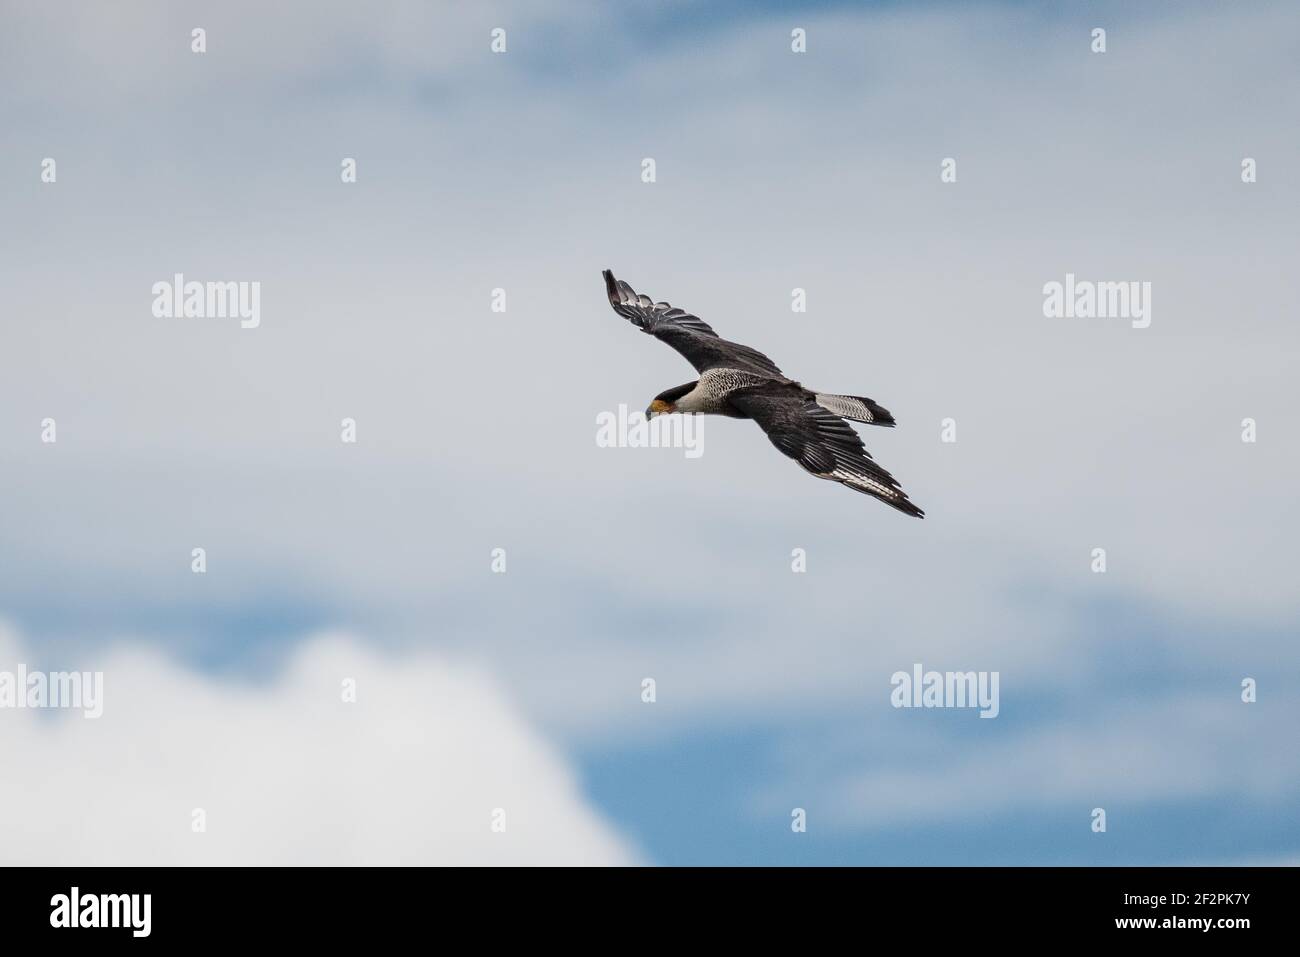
<box><xmin>0</xmin><ymin>631</ymin><xmax>638</xmax><ymax>865</ymax></box>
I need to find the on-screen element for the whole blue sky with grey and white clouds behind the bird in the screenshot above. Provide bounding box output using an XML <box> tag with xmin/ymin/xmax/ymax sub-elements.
<box><xmin>0</xmin><ymin>0</ymin><xmax>1300</xmax><ymax>863</ymax></box>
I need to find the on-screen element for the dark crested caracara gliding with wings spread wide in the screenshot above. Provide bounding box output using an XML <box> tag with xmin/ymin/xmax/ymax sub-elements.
<box><xmin>605</xmin><ymin>269</ymin><xmax>926</xmax><ymax>519</ymax></box>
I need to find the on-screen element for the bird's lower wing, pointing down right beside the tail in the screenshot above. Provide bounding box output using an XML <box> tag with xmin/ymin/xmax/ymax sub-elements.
<box><xmin>728</xmin><ymin>386</ymin><xmax>926</xmax><ymax>519</ymax></box>
